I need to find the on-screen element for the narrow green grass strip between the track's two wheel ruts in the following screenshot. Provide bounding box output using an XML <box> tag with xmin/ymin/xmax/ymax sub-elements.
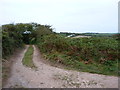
<box><xmin>22</xmin><ymin>45</ymin><xmax>35</xmax><ymax>68</ymax></box>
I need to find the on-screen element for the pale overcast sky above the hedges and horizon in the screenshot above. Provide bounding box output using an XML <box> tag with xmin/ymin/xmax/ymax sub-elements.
<box><xmin>0</xmin><ymin>0</ymin><xmax>119</xmax><ymax>33</ymax></box>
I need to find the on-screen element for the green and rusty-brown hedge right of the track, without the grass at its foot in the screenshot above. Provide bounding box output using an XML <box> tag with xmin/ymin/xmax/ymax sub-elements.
<box><xmin>38</xmin><ymin>34</ymin><xmax>118</xmax><ymax>61</ymax></box>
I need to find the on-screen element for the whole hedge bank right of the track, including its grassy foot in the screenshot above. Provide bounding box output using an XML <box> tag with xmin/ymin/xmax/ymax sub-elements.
<box><xmin>37</xmin><ymin>34</ymin><xmax>118</xmax><ymax>75</ymax></box>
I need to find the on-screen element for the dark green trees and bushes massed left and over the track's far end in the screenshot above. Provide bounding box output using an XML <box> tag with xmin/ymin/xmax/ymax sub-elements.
<box><xmin>0</xmin><ymin>23</ymin><xmax>52</xmax><ymax>58</ymax></box>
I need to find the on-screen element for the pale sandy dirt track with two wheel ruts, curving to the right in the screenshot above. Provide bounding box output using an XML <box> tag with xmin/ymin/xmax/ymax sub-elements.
<box><xmin>4</xmin><ymin>46</ymin><xmax>118</xmax><ymax>88</ymax></box>
